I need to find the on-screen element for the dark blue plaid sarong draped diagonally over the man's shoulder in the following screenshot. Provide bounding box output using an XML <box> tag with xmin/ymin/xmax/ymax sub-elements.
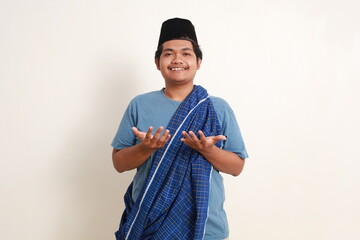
<box><xmin>115</xmin><ymin>86</ymin><xmax>221</xmax><ymax>240</ymax></box>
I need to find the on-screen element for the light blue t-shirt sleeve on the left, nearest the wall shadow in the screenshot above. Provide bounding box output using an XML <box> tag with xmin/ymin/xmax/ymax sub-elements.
<box><xmin>111</xmin><ymin>100</ymin><xmax>137</xmax><ymax>150</ymax></box>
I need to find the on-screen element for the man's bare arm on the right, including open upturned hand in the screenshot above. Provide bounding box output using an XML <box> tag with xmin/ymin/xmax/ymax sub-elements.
<box><xmin>182</xmin><ymin>131</ymin><xmax>245</xmax><ymax>176</ymax></box>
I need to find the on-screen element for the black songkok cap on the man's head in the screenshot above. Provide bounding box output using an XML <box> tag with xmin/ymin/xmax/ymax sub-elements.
<box><xmin>158</xmin><ymin>18</ymin><xmax>198</xmax><ymax>47</ymax></box>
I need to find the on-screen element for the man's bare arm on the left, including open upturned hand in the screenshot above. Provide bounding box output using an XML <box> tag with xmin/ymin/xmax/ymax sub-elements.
<box><xmin>112</xmin><ymin>127</ymin><xmax>170</xmax><ymax>172</ymax></box>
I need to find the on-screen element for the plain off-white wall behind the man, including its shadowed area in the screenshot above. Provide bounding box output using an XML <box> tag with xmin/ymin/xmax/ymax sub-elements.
<box><xmin>0</xmin><ymin>0</ymin><xmax>360</xmax><ymax>240</ymax></box>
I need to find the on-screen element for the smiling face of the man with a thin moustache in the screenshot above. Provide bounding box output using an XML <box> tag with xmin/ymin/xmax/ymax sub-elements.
<box><xmin>155</xmin><ymin>40</ymin><xmax>201</xmax><ymax>86</ymax></box>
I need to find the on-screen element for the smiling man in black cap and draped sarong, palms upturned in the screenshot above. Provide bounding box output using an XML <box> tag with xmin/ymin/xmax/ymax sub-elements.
<box><xmin>112</xmin><ymin>18</ymin><xmax>248</xmax><ymax>240</ymax></box>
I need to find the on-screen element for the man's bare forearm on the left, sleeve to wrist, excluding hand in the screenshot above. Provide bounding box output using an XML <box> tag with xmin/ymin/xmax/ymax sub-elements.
<box><xmin>112</xmin><ymin>143</ymin><xmax>155</xmax><ymax>173</ymax></box>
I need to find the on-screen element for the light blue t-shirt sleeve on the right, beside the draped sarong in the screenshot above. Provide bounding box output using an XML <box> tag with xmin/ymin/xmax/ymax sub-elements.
<box><xmin>214</xmin><ymin>98</ymin><xmax>249</xmax><ymax>159</ymax></box>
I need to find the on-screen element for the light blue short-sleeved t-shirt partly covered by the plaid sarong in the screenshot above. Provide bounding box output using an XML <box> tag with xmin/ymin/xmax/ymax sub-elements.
<box><xmin>111</xmin><ymin>90</ymin><xmax>248</xmax><ymax>240</ymax></box>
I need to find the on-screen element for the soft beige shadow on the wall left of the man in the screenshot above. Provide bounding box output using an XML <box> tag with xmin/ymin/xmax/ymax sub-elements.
<box><xmin>55</xmin><ymin>58</ymin><xmax>136</xmax><ymax>240</ymax></box>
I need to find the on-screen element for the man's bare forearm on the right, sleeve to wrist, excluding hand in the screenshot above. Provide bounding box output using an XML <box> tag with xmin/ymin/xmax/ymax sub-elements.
<box><xmin>199</xmin><ymin>145</ymin><xmax>245</xmax><ymax>176</ymax></box>
